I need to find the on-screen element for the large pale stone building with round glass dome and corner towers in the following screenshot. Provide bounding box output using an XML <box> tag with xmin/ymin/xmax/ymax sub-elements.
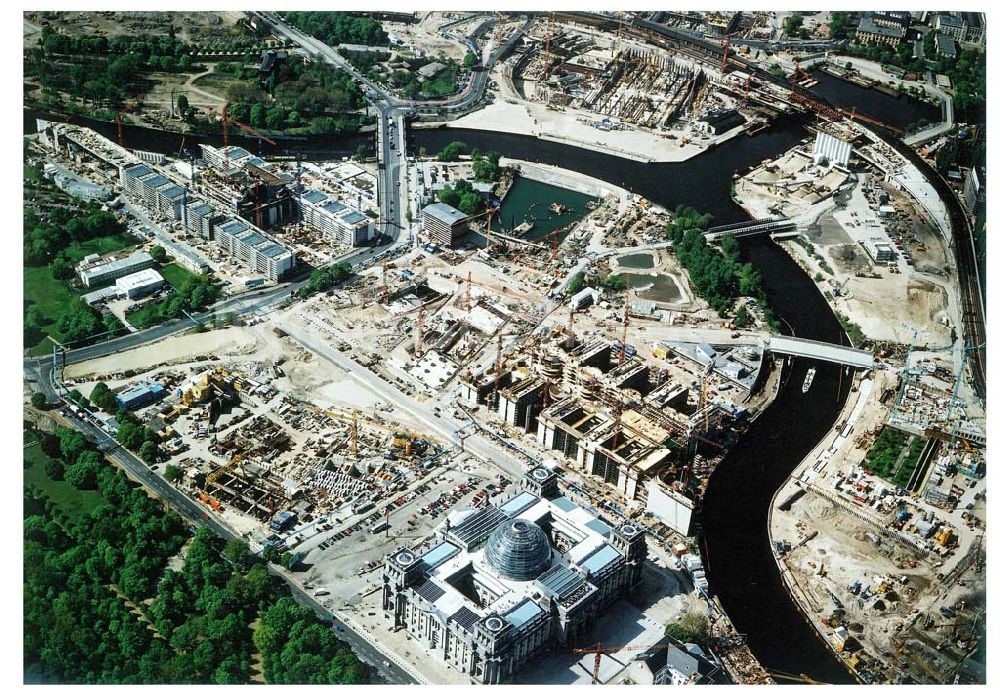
<box><xmin>382</xmin><ymin>466</ymin><xmax>647</xmax><ymax>684</ymax></box>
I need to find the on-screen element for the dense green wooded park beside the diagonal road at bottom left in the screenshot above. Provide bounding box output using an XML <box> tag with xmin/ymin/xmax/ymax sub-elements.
<box><xmin>23</xmin><ymin>429</ymin><xmax>370</xmax><ymax>684</ymax></box>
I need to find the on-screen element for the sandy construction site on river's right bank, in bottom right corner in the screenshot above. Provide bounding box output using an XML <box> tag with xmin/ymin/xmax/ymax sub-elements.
<box><xmin>771</xmin><ymin>364</ymin><xmax>986</xmax><ymax>683</ymax></box>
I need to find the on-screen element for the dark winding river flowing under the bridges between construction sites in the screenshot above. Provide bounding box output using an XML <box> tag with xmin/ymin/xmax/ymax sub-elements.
<box><xmin>24</xmin><ymin>85</ymin><xmax>919</xmax><ymax>683</ymax></box>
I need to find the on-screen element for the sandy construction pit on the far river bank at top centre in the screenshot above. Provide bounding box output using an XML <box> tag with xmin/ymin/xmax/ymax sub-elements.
<box><xmin>449</xmin><ymin>19</ymin><xmax>787</xmax><ymax>162</ymax></box>
